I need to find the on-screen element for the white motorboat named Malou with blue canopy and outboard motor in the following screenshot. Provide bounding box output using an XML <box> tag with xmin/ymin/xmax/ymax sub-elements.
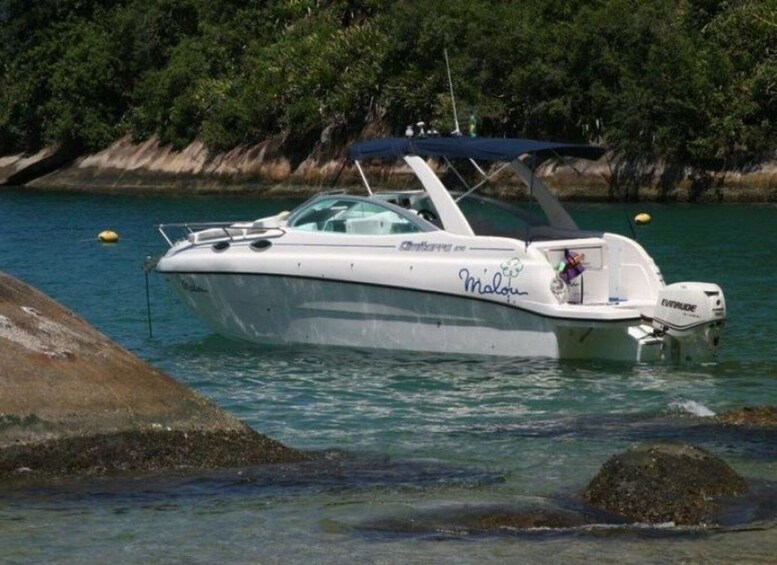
<box><xmin>156</xmin><ymin>137</ymin><xmax>726</xmax><ymax>362</ymax></box>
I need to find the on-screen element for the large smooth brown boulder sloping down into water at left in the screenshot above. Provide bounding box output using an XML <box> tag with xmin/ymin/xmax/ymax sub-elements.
<box><xmin>0</xmin><ymin>273</ymin><xmax>306</xmax><ymax>478</ymax></box>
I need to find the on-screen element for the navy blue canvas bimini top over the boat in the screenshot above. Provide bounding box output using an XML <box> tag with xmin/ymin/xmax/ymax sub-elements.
<box><xmin>349</xmin><ymin>137</ymin><xmax>606</xmax><ymax>161</ymax></box>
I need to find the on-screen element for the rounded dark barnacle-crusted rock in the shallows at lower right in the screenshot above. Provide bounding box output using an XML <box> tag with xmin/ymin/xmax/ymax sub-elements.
<box><xmin>583</xmin><ymin>443</ymin><xmax>748</xmax><ymax>525</ymax></box>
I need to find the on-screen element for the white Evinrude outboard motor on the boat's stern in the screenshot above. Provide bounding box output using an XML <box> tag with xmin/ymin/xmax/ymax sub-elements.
<box><xmin>653</xmin><ymin>282</ymin><xmax>726</xmax><ymax>362</ymax></box>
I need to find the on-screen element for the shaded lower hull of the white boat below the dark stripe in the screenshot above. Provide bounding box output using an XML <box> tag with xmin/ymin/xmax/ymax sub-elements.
<box><xmin>165</xmin><ymin>273</ymin><xmax>661</xmax><ymax>361</ymax></box>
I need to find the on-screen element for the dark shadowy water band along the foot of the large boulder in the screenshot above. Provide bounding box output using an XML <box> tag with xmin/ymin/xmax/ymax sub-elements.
<box><xmin>0</xmin><ymin>450</ymin><xmax>504</xmax><ymax>509</ymax></box>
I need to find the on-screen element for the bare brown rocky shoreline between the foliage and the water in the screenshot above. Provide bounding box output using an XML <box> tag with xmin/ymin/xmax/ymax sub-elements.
<box><xmin>0</xmin><ymin>136</ymin><xmax>777</xmax><ymax>202</ymax></box>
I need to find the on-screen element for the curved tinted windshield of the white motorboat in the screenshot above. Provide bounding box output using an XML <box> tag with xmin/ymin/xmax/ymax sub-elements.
<box><xmin>288</xmin><ymin>197</ymin><xmax>429</xmax><ymax>235</ymax></box>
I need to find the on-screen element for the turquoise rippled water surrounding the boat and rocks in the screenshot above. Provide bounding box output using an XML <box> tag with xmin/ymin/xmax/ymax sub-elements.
<box><xmin>0</xmin><ymin>190</ymin><xmax>777</xmax><ymax>563</ymax></box>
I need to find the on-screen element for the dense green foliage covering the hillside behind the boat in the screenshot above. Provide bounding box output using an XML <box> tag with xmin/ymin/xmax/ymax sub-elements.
<box><xmin>0</xmin><ymin>0</ymin><xmax>777</xmax><ymax>170</ymax></box>
